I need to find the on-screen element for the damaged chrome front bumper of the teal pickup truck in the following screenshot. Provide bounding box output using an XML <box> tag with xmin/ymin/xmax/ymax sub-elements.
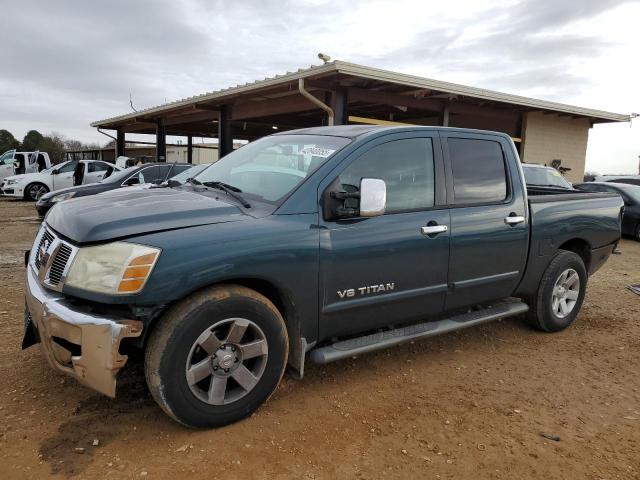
<box><xmin>23</xmin><ymin>265</ymin><xmax>143</xmax><ymax>397</ymax></box>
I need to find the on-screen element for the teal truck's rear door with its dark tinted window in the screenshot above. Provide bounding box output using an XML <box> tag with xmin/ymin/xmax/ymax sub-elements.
<box><xmin>441</xmin><ymin>132</ymin><xmax>529</xmax><ymax>309</ymax></box>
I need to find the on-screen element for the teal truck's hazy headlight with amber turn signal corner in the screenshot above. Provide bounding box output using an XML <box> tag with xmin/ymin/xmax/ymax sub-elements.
<box><xmin>65</xmin><ymin>242</ymin><xmax>160</xmax><ymax>295</ymax></box>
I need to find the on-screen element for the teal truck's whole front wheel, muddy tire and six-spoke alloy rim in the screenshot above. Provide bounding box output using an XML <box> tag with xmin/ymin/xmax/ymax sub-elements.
<box><xmin>145</xmin><ymin>285</ymin><xmax>289</xmax><ymax>428</ymax></box>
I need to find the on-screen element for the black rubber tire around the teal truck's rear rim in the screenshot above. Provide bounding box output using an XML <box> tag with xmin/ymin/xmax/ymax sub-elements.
<box><xmin>525</xmin><ymin>250</ymin><xmax>588</xmax><ymax>332</ymax></box>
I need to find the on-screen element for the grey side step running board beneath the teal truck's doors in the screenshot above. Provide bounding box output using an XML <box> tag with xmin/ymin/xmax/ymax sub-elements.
<box><xmin>309</xmin><ymin>301</ymin><xmax>529</xmax><ymax>363</ymax></box>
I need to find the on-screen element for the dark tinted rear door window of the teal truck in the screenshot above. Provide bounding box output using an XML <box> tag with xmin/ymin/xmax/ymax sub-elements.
<box><xmin>447</xmin><ymin>138</ymin><xmax>507</xmax><ymax>205</ymax></box>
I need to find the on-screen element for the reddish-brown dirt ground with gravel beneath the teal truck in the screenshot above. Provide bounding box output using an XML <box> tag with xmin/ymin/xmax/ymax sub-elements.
<box><xmin>0</xmin><ymin>199</ymin><xmax>640</xmax><ymax>479</ymax></box>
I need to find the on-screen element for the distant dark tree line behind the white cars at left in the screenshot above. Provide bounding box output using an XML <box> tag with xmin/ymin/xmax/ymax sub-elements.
<box><xmin>0</xmin><ymin>129</ymin><xmax>100</xmax><ymax>163</ymax></box>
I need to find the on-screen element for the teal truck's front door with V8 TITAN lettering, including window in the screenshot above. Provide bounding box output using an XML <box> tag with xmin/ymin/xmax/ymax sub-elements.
<box><xmin>319</xmin><ymin>133</ymin><xmax>449</xmax><ymax>338</ymax></box>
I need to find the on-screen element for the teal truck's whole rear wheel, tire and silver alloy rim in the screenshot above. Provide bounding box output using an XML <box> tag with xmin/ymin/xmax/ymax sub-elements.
<box><xmin>527</xmin><ymin>251</ymin><xmax>588</xmax><ymax>332</ymax></box>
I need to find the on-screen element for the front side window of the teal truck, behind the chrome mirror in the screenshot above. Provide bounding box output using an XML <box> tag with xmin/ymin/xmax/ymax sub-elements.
<box><xmin>339</xmin><ymin>138</ymin><xmax>435</xmax><ymax>213</ymax></box>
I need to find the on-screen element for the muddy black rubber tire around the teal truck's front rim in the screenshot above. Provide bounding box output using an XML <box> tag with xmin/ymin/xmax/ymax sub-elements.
<box><xmin>145</xmin><ymin>285</ymin><xmax>289</xmax><ymax>428</ymax></box>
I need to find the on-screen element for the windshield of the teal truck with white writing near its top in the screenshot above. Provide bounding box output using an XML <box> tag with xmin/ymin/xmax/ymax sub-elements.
<box><xmin>195</xmin><ymin>135</ymin><xmax>350</xmax><ymax>205</ymax></box>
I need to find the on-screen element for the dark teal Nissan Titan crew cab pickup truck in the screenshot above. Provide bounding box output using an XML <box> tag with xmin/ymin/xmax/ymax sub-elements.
<box><xmin>23</xmin><ymin>126</ymin><xmax>623</xmax><ymax>427</ymax></box>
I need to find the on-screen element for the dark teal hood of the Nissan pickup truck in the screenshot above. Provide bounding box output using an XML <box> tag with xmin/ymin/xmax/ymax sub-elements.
<box><xmin>46</xmin><ymin>188</ymin><xmax>253</xmax><ymax>243</ymax></box>
